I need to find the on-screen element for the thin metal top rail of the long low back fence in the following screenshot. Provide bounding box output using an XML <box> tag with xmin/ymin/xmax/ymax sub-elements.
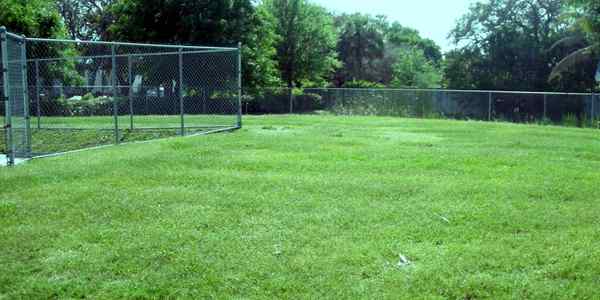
<box><xmin>265</xmin><ymin>87</ymin><xmax>596</xmax><ymax>96</ymax></box>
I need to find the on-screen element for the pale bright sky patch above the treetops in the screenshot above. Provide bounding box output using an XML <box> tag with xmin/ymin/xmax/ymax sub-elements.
<box><xmin>312</xmin><ymin>0</ymin><xmax>474</xmax><ymax>51</ymax></box>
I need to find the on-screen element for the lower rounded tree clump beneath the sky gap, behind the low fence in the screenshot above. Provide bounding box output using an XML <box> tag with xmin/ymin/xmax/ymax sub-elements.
<box><xmin>335</xmin><ymin>14</ymin><xmax>442</xmax><ymax>87</ymax></box>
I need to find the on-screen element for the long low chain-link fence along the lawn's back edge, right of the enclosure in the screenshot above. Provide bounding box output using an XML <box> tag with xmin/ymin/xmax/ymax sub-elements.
<box><xmin>242</xmin><ymin>88</ymin><xmax>600</xmax><ymax>127</ymax></box>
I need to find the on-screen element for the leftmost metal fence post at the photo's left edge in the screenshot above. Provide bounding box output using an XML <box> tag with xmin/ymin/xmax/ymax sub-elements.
<box><xmin>0</xmin><ymin>26</ymin><xmax>15</xmax><ymax>166</ymax></box>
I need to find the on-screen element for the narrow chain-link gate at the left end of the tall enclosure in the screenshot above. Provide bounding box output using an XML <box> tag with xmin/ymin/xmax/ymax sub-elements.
<box><xmin>0</xmin><ymin>27</ymin><xmax>31</xmax><ymax>165</ymax></box>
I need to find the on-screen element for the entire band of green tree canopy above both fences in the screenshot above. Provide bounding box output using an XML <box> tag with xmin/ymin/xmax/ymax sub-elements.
<box><xmin>0</xmin><ymin>0</ymin><xmax>600</xmax><ymax>91</ymax></box>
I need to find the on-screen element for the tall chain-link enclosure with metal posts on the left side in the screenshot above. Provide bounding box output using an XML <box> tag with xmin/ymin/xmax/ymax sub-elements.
<box><xmin>2</xmin><ymin>27</ymin><xmax>241</xmax><ymax>163</ymax></box>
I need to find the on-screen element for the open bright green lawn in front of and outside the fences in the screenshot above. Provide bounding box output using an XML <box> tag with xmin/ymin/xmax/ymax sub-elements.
<box><xmin>0</xmin><ymin>116</ymin><xmax>600</xmax><ymax>299</ymax></box>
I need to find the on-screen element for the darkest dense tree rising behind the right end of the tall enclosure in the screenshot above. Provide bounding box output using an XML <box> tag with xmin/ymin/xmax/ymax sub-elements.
<box><xmin>109</xmin><ymin>0</ymin><xmax>279</xmax><ymax>88</ymax></box>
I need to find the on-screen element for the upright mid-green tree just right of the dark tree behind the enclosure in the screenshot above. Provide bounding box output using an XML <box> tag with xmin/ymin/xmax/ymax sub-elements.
<box><xmin>261</xmin><ymin>0</ymin><xmax>340</xmax><ymax>87</ymax></box>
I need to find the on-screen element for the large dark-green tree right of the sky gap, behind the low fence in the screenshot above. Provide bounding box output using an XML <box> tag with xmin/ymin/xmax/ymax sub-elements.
<box><xmin>444</xmin><ymin>0</ymin><xmax>593</xmax><ymax>91</ymax></box>
